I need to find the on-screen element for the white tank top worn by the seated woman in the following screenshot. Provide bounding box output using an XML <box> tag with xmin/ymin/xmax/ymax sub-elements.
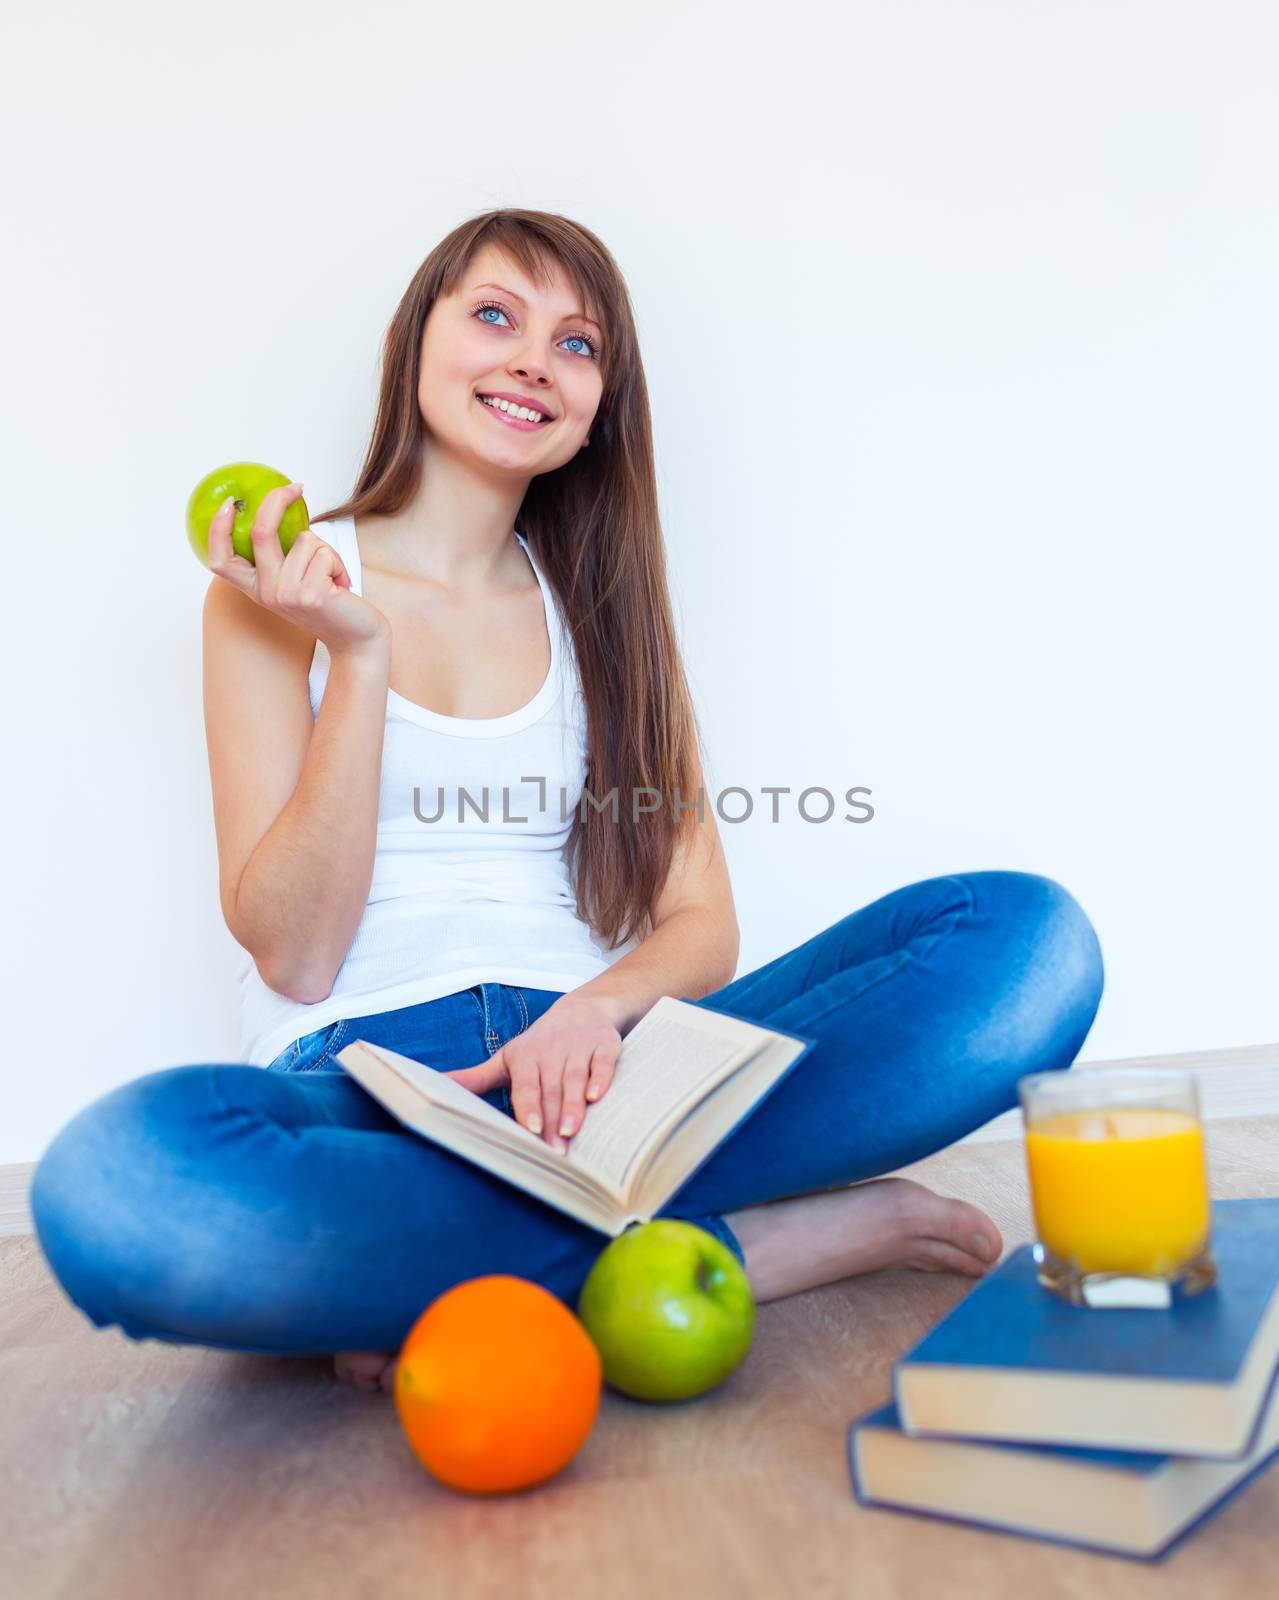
<box><xmin>239</xmin><ymin>517</ymin><xmax>639</xmax><ymax>1067</ymax></box>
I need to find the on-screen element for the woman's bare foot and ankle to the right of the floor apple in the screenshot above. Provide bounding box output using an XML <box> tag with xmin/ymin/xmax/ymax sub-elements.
<box><xmin>725</xmin><ymin>1178</ymin><xmax>1004</xmax><ymax>1301</ymax></box>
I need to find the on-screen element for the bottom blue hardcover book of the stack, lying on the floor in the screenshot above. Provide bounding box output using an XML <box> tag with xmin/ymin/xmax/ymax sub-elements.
<box><xmin>848</xmin><ymin>1363</ymin><xmax>1279</xmax><ymax>1560</ymax></box>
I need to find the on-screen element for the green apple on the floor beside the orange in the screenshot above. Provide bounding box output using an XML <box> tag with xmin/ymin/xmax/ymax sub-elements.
<box><xmin>578</xmin><ymin>1218</ymin><xmax>756</xmax><ymax>1400</ymax></box>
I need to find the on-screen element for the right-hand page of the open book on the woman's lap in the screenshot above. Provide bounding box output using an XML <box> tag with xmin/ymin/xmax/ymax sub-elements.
<box><xmin>563</xmin><ymin>998</ymin><xmax>759</xmax><ymax>1194</ymax></box>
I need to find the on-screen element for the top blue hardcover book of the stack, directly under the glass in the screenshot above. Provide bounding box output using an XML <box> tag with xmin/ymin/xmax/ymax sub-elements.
<box><xmin>893</xmin><ymin>1198</ymin><xmax>1279</xmax><ymax>1459</ymax></box>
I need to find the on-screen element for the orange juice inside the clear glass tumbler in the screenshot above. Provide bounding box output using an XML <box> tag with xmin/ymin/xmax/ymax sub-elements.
<box><xmin>1026</xmin><ymin>1106</ymin><xmax>1210</xmax><ymax>1277</ymax></box>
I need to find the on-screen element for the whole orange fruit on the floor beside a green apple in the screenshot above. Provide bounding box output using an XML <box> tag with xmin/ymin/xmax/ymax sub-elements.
<box><xmin>395</xmin><ymin>1272</ymin><xmax>603</xmax><ymax>1494</ymax></box>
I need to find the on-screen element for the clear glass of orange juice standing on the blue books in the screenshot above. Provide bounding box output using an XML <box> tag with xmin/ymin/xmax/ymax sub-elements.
<box><xmin>1018</xmin><ymin>1067</ymin><xmax>1217</xmax><ymax>1306</ymax></box>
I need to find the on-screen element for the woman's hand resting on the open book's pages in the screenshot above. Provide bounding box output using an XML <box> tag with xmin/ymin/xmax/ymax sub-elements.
<box><xmin>445</xmin><ymin>992</ymin><xmax>621</xmax><ymax>1150</ymax></box>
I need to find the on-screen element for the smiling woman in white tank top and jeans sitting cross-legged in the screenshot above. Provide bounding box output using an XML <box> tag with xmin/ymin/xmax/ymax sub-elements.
<box><xmin>32</xmin><ymin>210</ymin><xmax>1103</xmax><ymax>1389</ymax></box>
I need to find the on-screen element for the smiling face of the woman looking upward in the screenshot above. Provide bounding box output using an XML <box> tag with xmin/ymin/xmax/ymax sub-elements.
<box><xmin>418</xmin><ymin>245</ymin><xmax>603</xmax><ymax>478</ymax></box>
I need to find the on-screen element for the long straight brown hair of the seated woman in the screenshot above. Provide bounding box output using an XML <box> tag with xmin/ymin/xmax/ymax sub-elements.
<box><xmin>311</xmin><ymin>208</ymin><xmax>701</xmax><ymax>949</ymax></box>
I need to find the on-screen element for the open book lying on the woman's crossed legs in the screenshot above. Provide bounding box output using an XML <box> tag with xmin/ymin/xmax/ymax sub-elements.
<box><xmin>335</xmin><ymin>995</ymin><xmax>816</xmax><ymax>1235</ymax></box>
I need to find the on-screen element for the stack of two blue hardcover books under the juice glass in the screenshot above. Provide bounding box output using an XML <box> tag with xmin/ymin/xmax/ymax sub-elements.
<box><xmin>848</xmin><ymin>1200</ymin><xmax>1279</xmax><ymax>1560</ymax></box>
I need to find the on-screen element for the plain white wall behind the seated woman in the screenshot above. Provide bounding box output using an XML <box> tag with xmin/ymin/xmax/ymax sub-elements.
<box><xmin>0</xmin><ymin>0</ymin><xmax>1279</xmax><ymax>1162</ymax></box>
